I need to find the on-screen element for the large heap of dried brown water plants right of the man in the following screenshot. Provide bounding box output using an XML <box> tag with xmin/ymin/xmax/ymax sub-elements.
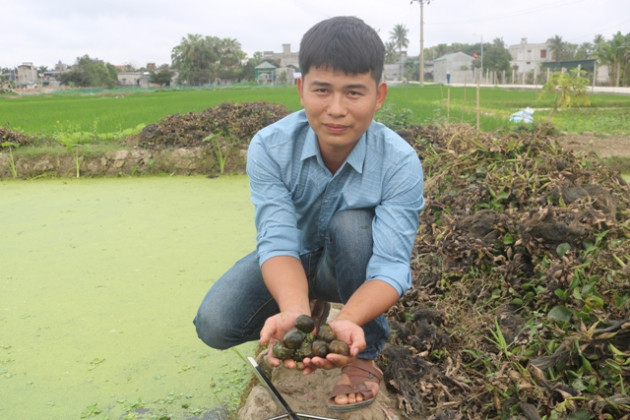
<box><xmin>386</xmin><ymin>125</ymin><xmax>630</xmax><ymax>419</ymax></box>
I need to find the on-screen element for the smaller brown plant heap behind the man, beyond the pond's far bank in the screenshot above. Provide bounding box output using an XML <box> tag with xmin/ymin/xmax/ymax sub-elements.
<box><xmin>137</xmin><ymin>101</ymin><xmax>289</xmax><ymax>149</ymax></box>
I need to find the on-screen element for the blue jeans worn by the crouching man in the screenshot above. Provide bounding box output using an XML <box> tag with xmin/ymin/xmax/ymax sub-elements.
<box><xmin>194</xmin><ymin>210</ymin><xmax>389</xmax><ymax>359</ymax></box>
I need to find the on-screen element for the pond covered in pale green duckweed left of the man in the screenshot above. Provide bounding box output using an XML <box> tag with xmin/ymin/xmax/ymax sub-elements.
<box><xmin>0</xmin><ymin>176</ymin><xmax>255</xmax><ymax>419</ymax></box>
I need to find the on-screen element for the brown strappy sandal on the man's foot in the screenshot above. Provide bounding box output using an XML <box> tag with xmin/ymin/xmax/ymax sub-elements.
<box><xmin>327</xmin><ymin>359</ymin><xmax>383</xmax><ymax>412</ymax></box>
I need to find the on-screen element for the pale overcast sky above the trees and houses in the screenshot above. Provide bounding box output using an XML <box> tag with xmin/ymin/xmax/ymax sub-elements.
<box><xmin>0</xmin><ymin>0</ymin><xmax>630</xmax><ymax>68</ymax></box>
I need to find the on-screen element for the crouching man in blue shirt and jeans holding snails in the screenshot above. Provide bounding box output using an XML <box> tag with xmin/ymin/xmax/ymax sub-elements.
<box><xmin>195</xmin><ymin>17</ymin><xmax>424</xmax><ymax>411</ymax></box>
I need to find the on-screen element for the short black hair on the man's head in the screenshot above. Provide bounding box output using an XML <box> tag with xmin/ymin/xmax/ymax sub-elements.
<box><xmin>299</xmin><ymin>16</ymin><xmax>385</xmax><ymax>83</ymax></box>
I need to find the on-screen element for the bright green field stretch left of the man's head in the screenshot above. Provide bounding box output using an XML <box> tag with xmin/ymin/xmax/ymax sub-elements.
<box><xmin>0</xmin><ymin>88</ymin><xmax>299</xmax><ymax>137</ymax></box>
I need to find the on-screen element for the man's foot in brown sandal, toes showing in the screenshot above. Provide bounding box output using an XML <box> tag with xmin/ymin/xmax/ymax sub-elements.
<box><xmin>327</xmin><ymin>359</ymin><xmax>383</xmax><ymax>411</ymax></box>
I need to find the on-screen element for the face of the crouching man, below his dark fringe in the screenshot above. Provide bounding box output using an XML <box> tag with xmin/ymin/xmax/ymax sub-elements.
<box><xmin>298</xmin><ymin>67</ymin><xmax>387</xmax><ymax>160</ymax></box>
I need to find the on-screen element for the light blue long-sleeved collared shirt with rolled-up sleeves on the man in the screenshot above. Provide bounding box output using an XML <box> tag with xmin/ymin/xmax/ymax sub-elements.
<box><xmin>247</xmin><ymin>111</ymin><xmax>424</xmax><ymax>295</ymax></box>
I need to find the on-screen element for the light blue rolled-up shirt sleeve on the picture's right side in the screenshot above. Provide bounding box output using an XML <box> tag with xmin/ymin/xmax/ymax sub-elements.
<box><xmin>366</xmin><ymin>153</ymin><xmax>424</xmax><ymax>296</ymax></box>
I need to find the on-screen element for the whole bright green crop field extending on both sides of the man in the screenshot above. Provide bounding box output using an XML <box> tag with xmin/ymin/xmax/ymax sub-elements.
<box><xmin>0</xmin><ymin>85</ymin><xmax>630</xmax><ymax>139</ymax></box>
